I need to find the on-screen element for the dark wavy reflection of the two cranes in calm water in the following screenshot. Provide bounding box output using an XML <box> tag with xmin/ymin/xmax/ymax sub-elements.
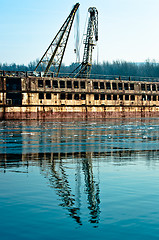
<box><xmin>41</xmin><ymin>153</ymin><xmax>100</xmax><ymax>226</ymax></box>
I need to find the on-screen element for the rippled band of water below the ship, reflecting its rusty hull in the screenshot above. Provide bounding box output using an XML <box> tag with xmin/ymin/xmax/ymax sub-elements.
<box><xmin>0</xmin><ymin>119</ymin><xmax>159</xmax><ymax>153</ymax></box>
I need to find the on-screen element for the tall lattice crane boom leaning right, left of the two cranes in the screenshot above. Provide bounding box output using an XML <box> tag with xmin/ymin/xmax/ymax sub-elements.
<box><xmin>35</xmin><ymin>3</ymin><xmax>80</xmax><ymax>77</ymax></box>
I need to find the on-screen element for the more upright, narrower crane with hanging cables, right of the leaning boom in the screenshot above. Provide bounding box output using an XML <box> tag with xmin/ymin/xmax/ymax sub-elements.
<box><xmin>73</xmin><ymin>7</ymin><xmax>98</xmax><ymax>78</ymax></box>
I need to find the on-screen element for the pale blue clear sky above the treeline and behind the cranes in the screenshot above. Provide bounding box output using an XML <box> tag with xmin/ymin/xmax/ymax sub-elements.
<box><xmin>0</xmin><ymin>0</ymin><xmax>159</xmax><ymax>65</ymax></box>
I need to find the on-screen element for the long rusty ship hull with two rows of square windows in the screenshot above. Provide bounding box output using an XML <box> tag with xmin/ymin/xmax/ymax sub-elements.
<box><xmin>0</xmin><ymin>75</ymin><xmax>159</xmax><ymax>120</ymax></box>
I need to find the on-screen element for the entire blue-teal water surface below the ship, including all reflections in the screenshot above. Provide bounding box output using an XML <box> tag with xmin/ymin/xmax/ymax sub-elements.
<box><xmin>0</xmin><ymin>119</ymin><xmax>159</xmax><ymax>240</ymax></box>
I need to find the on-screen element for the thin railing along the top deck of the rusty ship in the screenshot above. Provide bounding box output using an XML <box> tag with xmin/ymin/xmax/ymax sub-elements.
<box><xmin>0</xmin><ymin>70</ymin><xmax>159</xmax><ymax>82</ymax></box>
